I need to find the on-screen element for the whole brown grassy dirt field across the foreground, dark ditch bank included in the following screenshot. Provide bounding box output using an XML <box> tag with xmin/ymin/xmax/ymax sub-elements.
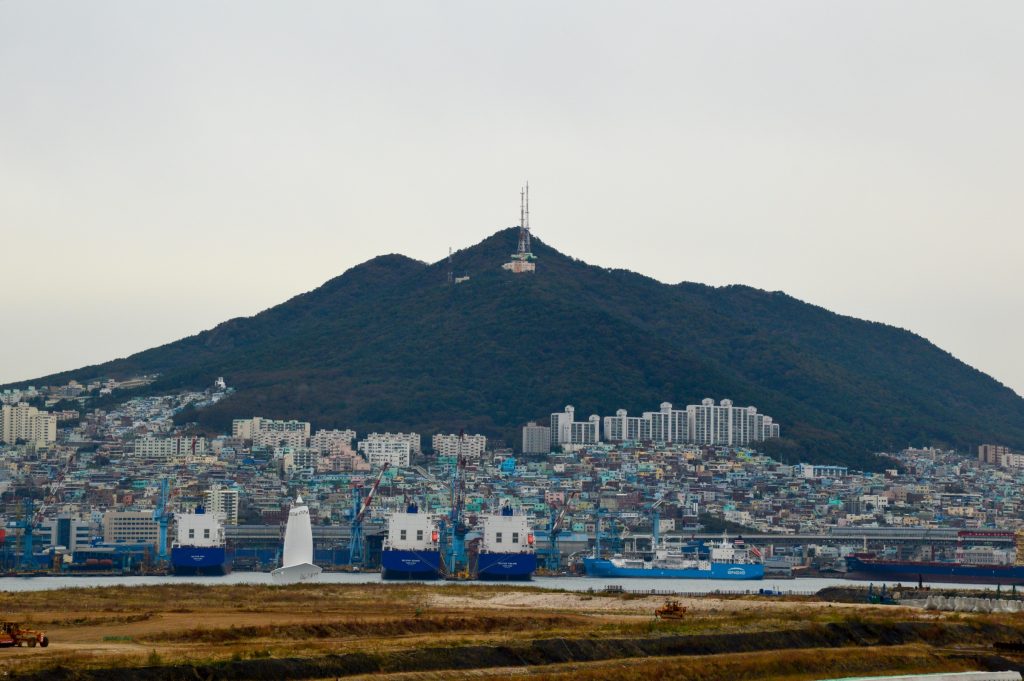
<box><xmin>0</xmin><ymin>584</ymin><xmax>1024</xmax><ymax>681</ymax></box>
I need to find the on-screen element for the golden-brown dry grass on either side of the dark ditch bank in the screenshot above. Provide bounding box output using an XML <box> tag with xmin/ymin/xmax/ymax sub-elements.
<box><xmin>0</xmin><ymin>584</ymin><xmax>1024</xmax><ymax>681</ymax></box>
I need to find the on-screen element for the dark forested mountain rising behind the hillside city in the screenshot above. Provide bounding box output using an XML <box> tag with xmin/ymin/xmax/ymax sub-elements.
<box><xmin>14</xmin><ymin>228</ymin><xmax>1024</xmax><ymax>468</ymax></box>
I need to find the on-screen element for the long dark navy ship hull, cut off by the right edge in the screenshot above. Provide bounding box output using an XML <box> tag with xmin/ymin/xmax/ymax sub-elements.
<box><xmin>845</xmin><ymin>556</ymin><xmax>1024</xmax><ymax>586</ymax></box>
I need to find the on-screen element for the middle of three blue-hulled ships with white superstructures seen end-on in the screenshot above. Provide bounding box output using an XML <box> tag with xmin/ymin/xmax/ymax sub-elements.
<box><xmin>381</xmin><ymin>503</ymin><xmax>441</xmax><ymax>580</ymax></box>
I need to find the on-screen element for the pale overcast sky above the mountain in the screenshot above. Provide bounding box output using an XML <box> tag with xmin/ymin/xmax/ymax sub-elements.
<box><xmin>0</xmin><ymin>0</ymin><xmax>1024</xmax><ymax>399</ymax></box>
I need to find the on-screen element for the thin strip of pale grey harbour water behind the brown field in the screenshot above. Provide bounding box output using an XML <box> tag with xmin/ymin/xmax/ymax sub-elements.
<box><xmin>0</xmin><ymin>572</ymin><xmax>1008</xmax><ymax>595</ymax></box>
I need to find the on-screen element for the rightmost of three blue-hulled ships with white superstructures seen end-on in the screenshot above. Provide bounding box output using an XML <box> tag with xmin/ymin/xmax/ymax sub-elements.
<box><xmin>476</xmin><ymin>504</ymin><xmax>537</xmax><ymax>581</ymax></box>
